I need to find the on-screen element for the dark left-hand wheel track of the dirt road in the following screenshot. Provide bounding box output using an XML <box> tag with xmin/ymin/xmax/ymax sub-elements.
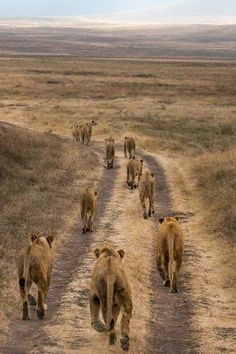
<box><xmin>0</xmin><ymin>144</ymin><xmax>117</xmax><ymax>354</ymax></box>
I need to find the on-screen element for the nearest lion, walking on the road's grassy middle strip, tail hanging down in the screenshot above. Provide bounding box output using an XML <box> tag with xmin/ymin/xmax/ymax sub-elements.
<box><xmin>90</xmin><ymin>245</ymin><xmax>133</xmax><ymax>351</ymax></box>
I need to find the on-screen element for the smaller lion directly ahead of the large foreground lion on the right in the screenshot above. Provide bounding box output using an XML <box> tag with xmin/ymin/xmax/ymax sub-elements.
<box><xmin>139</xmin><ymin>171</ymin><xmax>155</xmax><ymax>219</ymax></box>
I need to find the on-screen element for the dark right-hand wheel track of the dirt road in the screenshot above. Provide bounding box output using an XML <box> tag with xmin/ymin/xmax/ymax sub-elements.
<box><xmin>140</xmin><ymin>152</ymin><xmax>198</xmax><ymax>354</ymax></box>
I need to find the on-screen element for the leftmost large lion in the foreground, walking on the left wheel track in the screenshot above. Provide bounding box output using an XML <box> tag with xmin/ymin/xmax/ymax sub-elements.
<box><xmin>18</xmin><ymin>234</ymin><xmax>55</xmax><ymax>320</ymax></box>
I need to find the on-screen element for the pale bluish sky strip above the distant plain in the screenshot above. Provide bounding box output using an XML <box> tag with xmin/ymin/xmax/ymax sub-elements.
<box><xmin>0</xmin><ymin>0</ymin><xmax>236</xmax><ymax>23</ymax></box>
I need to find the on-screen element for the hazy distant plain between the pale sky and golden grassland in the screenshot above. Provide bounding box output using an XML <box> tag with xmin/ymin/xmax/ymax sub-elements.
<box><xmin>0</xmin><ymin>23</ymin><xmax>236</xmax><ymax>60</ymax></box>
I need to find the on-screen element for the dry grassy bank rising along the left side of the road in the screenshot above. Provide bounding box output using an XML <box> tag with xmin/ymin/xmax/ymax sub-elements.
<box><xmin>0</xmin><ymin>124</ymin><xmax>99</xmax><ymax>333</ymax></box>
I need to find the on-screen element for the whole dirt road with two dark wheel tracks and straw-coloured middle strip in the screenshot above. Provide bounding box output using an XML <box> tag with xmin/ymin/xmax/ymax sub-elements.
<box><xmin>0</xmin><ymin>144</ymin><xmax>234</xmax><ymax>354</ymax></box>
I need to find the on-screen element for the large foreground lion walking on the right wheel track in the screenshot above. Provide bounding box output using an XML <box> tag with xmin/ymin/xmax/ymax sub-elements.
<box><xmin>157</xmin><ymin>217</ymin><xmax>184</xmax><ymax>293</ymax></box>
